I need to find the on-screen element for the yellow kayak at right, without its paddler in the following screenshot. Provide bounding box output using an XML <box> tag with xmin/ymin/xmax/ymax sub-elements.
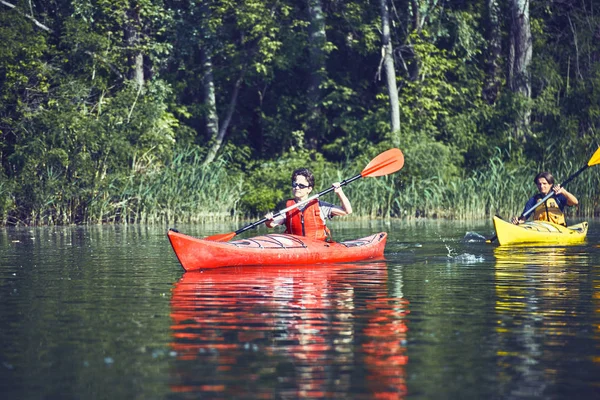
<box><xmin>494</xmin><ymin>217</ymin><xmax>588</xmax><ymax>245</ymax></box>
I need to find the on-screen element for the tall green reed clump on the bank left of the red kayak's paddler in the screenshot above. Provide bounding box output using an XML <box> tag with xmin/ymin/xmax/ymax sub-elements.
<box><xmin>89</xmin><ymin>148</ymin><xmax>243</xmax><ymax>224</ymax></box>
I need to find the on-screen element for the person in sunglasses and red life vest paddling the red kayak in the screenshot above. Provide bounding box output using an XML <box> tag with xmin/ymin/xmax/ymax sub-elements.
<box><xmin>265</xmin><ymin>168</ymin><xmax>352</xmax><ymax>240</ymax></box>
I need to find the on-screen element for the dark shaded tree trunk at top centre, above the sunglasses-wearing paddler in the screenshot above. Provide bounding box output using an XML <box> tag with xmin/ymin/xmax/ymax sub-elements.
<box><xmin>306</xmin><ymin>0</ymin><xmax>327</xmax><ymax>148</ymax></box>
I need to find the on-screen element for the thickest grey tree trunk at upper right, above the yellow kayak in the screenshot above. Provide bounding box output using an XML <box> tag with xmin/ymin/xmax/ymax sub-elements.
<box><xmin>508</xmin><ymin>0</ymin><xmax>533</xmax><ymax>140</ymax></box>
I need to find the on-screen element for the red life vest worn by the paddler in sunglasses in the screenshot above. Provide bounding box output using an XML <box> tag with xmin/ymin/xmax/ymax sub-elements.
<box><xmin>285</xmin><ymin>199</ymin><xmax>331</xmax><ymax>240</ymax></box>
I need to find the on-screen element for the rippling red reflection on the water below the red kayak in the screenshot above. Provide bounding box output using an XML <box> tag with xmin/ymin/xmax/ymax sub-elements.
<box><xmin>171</xmin><ymin>262</ymin><xmax>409</xmax><ymax>399</ymax></box>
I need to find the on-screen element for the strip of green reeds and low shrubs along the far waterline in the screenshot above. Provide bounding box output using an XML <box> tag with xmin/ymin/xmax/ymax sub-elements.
<box><xmin>0</xmin><ymin>148</ymin><xmax>600</xmax><ymax>226</ymax></box>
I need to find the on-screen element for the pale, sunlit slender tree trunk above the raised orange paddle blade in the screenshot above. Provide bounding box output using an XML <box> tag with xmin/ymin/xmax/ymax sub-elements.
<box><xmin>380</xmin><ymin>0</ymin><xmax>400</xmax><ymax>133</ymax></box>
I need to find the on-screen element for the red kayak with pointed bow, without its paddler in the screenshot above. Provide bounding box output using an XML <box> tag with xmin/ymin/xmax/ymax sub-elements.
<box><xmin>168</xmin><ymin>229</ymin><xmax>387</xmax><ymax>271</ymax></box>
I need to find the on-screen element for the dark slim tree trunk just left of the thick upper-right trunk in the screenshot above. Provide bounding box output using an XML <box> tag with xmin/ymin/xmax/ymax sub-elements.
<box><xmin>482</xmin><ymin>0</ymin><xmax>502</xmax><ymax>104</ymax></box>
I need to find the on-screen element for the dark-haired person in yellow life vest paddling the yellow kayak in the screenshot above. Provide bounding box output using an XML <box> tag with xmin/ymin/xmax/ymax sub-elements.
<box><xmin>512</xmin><ymin>172</ymin><xmax>579</xmax><ymax>226</ymax></box>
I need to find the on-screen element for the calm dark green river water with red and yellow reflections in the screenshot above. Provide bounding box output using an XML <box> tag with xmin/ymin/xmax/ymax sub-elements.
<box><xmin>0</xmin><ymin>221</ymin><xmax>600</xmax><ymax>399</ymax></box>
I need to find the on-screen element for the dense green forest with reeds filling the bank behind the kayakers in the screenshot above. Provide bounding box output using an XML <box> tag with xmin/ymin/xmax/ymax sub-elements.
<box><xmin>0</xmin><ymin>0</ymin><xmax>600</xmax><ymax>226</ymax></box>
